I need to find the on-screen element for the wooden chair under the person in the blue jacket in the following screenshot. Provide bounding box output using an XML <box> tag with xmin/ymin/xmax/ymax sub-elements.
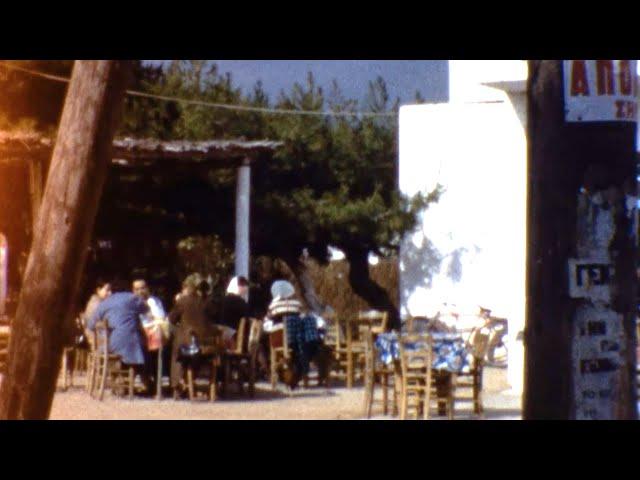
<box><xmin>89</xmin><ymin>322</ymin><xmax>135</xmax><ymax>400</ymax></box>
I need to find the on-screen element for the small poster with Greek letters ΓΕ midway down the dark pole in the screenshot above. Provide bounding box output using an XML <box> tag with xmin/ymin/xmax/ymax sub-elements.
<box><xmin>569</xmin><ymin>258</ymin><xmax>614</xmax><ymax>302</ymax></box>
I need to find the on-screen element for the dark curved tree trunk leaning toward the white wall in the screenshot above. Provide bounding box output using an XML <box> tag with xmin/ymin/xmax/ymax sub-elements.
<box><xmin>343</xmin><ymin>248</ymin><xmax>400</xmax><ymax>329</ymax></box>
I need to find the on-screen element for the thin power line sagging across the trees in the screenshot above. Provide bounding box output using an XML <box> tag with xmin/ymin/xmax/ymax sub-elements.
<box><xmin>0</xmin><ymin>62</ymin><xmax>397</xmax><ymax>117</ymax></box>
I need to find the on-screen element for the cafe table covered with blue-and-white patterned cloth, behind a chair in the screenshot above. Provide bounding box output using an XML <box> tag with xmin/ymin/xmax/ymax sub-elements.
<box><xmin>374</xmin><ymin>332</ymin><xmax>471</xmax><ymax>415</ymax></box>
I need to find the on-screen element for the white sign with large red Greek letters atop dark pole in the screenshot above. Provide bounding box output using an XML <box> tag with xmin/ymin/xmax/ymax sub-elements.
<box><xmin>563</xmin><ymin>60</ymin><xmax>638</xmax><ymax>122</ymax></box>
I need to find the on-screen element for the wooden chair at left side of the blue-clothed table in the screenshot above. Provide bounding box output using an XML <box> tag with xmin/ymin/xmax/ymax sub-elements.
<box><xmin>364</xmin><ymin>330</ymin><xmax>398</xmax><ymax>418</ymax></box>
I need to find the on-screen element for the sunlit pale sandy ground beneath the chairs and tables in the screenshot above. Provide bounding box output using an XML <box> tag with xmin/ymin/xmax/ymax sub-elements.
<box><xmin>51</xmin><ymin>369</ymin><xmax>520</xmax><ymax>420</ymax></box>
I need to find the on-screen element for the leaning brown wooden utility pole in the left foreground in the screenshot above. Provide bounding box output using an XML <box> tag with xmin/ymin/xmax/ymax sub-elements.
<box><xmin>0</xmin><ymin>60</ymin><xmax>130</xmax><ymax>419</ymax></box>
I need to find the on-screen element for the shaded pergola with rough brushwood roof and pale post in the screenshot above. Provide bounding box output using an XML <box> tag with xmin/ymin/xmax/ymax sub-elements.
<box><xmin>0</xmin><ymin>132</ymin><xmax>282</xmax><ymax>312</ymax></box>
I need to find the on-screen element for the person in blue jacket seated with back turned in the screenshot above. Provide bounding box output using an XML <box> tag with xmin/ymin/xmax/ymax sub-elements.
<box><xmin>88</xmin><ymin>285</ymin><xmax>149</xmax><ymax>390</ymax></box>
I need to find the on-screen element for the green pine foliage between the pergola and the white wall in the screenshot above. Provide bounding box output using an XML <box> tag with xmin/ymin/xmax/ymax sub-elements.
<box><xmin>116</xmin><ymin>61</ymin><xmax>439</xmax><ymax>263</ymax></box>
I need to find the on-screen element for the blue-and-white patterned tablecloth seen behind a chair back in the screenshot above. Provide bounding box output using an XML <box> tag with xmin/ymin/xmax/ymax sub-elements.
<box><xmin>375</xmin><ymin>332</ymin><xmax>471</xmax><ymax>373</ymax></box>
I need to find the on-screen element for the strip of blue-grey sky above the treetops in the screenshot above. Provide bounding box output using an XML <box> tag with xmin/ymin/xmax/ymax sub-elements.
<box><xmin>145</xmin><ymin>60</ymin><xmax>448</xmax><ymax>104</ymax></box>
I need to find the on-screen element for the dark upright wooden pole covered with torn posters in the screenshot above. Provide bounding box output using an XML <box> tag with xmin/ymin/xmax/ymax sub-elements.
<box><xmin>523</xmin><ymin>60</ymin><xmax>638</xmax><ymax>420</ymax></box>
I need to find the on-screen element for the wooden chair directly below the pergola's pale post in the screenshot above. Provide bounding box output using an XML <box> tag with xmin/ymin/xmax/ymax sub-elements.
<box><xmin>222</xmin><ymin>318</ymin><xmax>262</xmax><ymax>398</ymax></box>
